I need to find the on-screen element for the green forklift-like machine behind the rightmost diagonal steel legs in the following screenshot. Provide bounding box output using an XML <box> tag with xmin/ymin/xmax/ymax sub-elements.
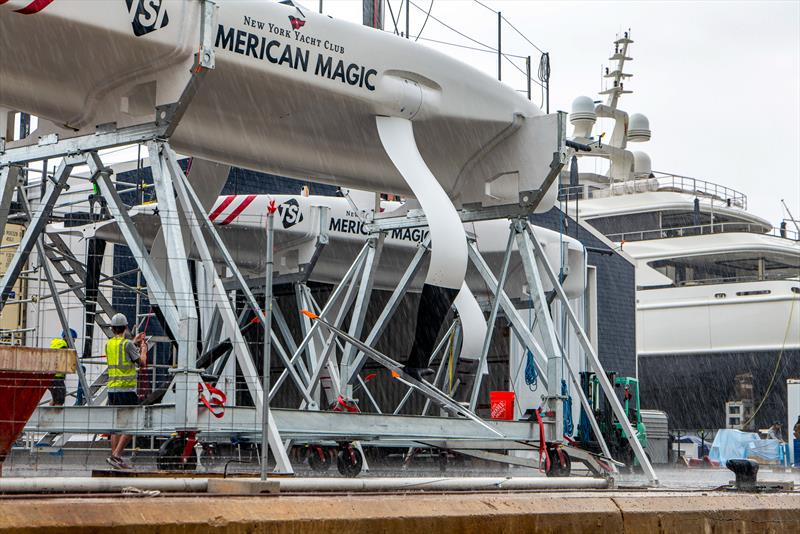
<box><xmin>577</xmin><ymin>372</ymin><xmax>649</xmax><ymax>469</ymax></box>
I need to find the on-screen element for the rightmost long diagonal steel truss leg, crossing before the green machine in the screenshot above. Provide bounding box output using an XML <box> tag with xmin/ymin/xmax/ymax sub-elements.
<box><xmin>525</xmin><ymin>226</ymin><xmax>658</xmax><ymax>484</ymax></box>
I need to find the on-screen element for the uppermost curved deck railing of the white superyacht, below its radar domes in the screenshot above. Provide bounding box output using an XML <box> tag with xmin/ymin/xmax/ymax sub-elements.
<box><xmin>558</xmin><ymin>171</ymin><xmax>747</xmax><ymax>210</ymax></box>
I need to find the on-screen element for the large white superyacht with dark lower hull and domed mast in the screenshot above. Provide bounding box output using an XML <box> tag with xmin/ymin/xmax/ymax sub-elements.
<box><xmin>561</xmin><ymin>34</ymin><xmax>800</xmax><ymax>430</ymax></box>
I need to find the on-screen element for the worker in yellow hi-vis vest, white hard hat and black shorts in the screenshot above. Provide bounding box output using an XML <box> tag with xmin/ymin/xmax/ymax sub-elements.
<box><xmin>106</xmin><ymin>313</ymin><xmax>147</xmax><ymax>469</ymax></box>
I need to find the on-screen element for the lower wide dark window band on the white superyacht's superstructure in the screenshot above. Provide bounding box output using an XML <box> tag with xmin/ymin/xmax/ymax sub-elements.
<box><xmin>648</xmin><ymin>252</ymin><xmax>800</xmax><ymax>286</ymax></box>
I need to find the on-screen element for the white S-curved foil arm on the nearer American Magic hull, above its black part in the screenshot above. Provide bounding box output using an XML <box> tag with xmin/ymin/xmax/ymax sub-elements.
<box><xmin>375</xmin><ymin>117</ymin><xmax>467</xmax><ymax>289</ymax></box>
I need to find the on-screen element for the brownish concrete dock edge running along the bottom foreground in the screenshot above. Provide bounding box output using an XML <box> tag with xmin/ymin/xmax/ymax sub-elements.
<box><xmin>0</xmin><ymin>490</ymin><xmax>800</xmax><ymax>534</ymax></box>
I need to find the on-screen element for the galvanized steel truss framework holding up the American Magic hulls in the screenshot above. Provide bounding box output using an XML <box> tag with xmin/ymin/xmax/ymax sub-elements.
<box><xmin>0</xmin><ymin>2</ymin><xmax>657</xmax><ymax>483</ymax></box>
